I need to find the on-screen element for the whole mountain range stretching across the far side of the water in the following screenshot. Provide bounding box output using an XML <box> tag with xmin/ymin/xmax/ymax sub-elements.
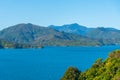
<box><xmin>0</xmin><ymin>23</ymin><xmax>120</xmax><ymax>46</ymax></box>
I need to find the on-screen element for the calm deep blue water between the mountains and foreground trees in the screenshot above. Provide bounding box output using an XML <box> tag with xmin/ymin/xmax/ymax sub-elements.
<box><xmin>0</xmin><ymin>46</ymin><xmax>120</xmax><ymax>80</ymax></box>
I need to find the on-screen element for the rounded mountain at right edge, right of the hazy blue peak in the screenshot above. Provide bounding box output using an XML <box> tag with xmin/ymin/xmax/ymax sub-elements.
<box><xmin>86</xmin><ymin>27</ymin><xmax>120</xmax><ymax>45</ymax></box>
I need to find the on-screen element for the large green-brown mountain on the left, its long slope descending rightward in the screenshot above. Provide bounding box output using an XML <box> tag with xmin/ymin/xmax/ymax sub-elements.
<box><xmin>0</xmin><ymin>23</ymin><xmax>100</xmax><ymax>46</ymax></box>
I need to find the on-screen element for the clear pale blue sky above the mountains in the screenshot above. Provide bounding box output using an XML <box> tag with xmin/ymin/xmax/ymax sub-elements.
<box><xmin>0</xmin><ymin>0</ymin><xmax>120</xmax><ymax>29</ymax></box>
